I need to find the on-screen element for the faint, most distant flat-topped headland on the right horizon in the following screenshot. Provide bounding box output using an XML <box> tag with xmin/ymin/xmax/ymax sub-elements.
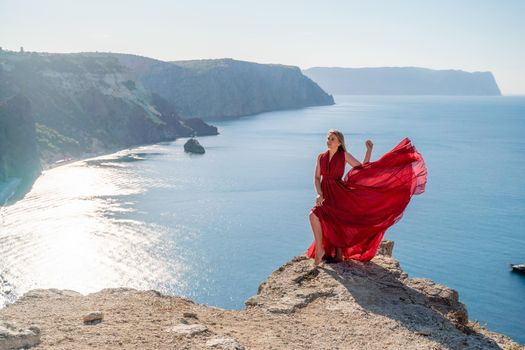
<box><xmin>304</xmin><ymin>67</ymin><xmax>501</xmax><ymax>96</ymax></box>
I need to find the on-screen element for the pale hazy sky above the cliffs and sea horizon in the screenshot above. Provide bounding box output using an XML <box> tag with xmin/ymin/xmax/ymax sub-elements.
<box><xmin>0</xmin><ymin>0</ymin><xmax>525</xmax><ymax>94</ymax></box>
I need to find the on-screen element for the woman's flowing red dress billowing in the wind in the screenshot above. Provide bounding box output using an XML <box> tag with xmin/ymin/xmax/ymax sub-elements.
<box><xmin>306</xmin><ymin>137</ymin><xmax>427</xmax><ymax>261</ymax></box>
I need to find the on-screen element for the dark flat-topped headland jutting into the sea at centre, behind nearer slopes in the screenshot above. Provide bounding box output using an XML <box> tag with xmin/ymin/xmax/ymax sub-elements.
<box><xmin>109</xmin><ymin>54</ymin><xmax>334</xmax><ymax>120</ymax></box>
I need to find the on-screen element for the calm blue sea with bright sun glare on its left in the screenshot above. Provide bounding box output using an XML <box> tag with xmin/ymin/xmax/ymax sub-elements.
<box><xmin>0</xmin><ymin>96</ymin><xmax>525</xmax><ymax>343</ymax></box>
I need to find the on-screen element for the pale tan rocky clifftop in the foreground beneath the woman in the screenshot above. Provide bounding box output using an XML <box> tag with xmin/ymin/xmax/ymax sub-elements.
<box><xmin>0</xmin><ymin>241</ymin><xmax>525</xmax><ymax>350</ymax></box>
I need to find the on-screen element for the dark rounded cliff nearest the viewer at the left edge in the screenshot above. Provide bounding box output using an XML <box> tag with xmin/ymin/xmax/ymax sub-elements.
<box><xmin>0</xmin><ymin>95</ymin><xmax>40</xmax><ymax>194</ymax></box>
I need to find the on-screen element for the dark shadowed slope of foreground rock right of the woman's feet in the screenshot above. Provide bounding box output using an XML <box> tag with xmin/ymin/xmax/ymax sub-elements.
<box><xmin>321</xmin><ymin>257</ymin><xmax>500</xmax><ymax>349</ymax></box>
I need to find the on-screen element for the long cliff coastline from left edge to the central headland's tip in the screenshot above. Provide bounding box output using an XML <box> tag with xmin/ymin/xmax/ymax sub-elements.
<box><xmin>0</xmin><ymin>51</ymin><xmax>334</xmax><ymax>201</ymax></box>
